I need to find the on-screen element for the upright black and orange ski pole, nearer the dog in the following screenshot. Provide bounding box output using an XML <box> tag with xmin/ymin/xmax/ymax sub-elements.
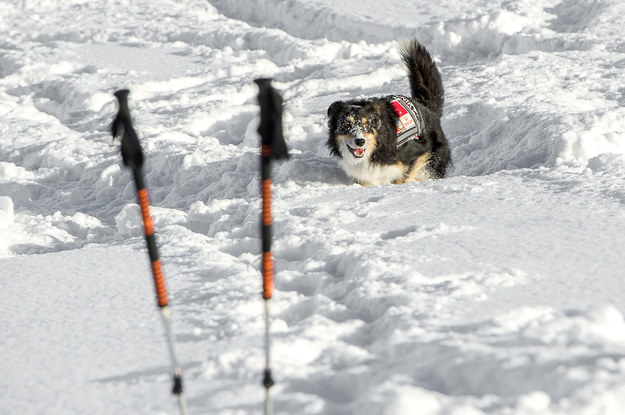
<box><xmin>254</xmin><ymin>78</ymin><xmax>289</xmax><ymax>415</ymax></box>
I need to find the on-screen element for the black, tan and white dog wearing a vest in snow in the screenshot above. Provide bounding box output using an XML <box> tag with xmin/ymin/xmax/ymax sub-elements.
<box><xmin>326</xmin><ymin>40</ymin><xmax>451</xmax><ymax>186</ymax></box>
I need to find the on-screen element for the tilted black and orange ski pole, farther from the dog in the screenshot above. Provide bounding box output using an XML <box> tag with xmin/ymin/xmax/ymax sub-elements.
<box><xmin>111</xmin><ymin>89</ymin><xmax>187</xmax><ymax>415</ymax></box>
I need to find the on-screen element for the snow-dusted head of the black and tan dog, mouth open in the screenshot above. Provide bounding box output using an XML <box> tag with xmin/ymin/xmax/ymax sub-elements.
<box><xmin>327</xmin><ymin>101</ymin><xmax>382</xmax><ymax>163</ymax></box>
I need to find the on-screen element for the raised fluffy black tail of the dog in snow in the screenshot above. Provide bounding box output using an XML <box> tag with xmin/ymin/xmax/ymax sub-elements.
<box><xmin>399</xmin><ymin>39</ymin><xmax>445</xmax><ymax>117</ymax></box>
